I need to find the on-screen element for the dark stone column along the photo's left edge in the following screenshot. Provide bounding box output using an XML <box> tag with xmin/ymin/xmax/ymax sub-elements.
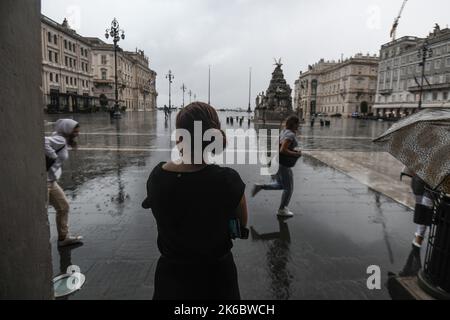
<box><xmin>0</xmin><ymin>0</ymin><xmax>53</xmax><ymax>300</ymax></box>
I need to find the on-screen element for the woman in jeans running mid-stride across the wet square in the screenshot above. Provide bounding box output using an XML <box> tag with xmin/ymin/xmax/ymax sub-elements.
<box><xmin>252</xmin><ymin>116</ymin><xmax>302</xmax><ymax>217</ymax></box>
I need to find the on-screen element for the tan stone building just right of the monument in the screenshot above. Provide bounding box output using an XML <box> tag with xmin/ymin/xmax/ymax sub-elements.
<box><xmin>295</xmin><ymin>54</ymin><xmax>379</xmax><ymax>118</ymax></box>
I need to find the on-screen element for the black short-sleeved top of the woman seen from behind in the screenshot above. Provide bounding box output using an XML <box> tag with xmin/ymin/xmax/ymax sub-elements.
<box><xmin>143</xmin><ymin>163</ymin><xmax>245</xmax><ymax>261</ymax></box>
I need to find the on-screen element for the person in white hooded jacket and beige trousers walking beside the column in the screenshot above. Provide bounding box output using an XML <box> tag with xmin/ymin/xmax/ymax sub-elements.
<box><xmin>45</xmin><ymin>119</ymin><xmax>83</xmax><ymax>247</ymax></box>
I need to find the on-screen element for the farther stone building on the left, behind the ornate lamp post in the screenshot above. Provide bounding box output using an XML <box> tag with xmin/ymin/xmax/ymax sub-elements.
<box><xmin>88</xmin><ymin>38</ymin><xmax>158</xmax><ymax>111</ymax></box>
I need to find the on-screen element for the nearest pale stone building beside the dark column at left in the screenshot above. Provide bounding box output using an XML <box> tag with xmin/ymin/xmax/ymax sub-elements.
<box><xmin>41</xmin><ymin>16</ymin><xmax>95</xmax><ymax>112</ymax></box>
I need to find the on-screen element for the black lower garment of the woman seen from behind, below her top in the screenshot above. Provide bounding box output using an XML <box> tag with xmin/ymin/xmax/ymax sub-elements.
<box><xmin>153</xmin><ymin>253</ymin><xmax>241</xmax><ymax>300</ymax></box>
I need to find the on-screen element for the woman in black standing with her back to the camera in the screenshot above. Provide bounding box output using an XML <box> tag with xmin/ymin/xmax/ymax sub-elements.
<box><xmin>142</xmin><ymin>102</ymin><xmax>247</xmax><ymax>300</ymax></box>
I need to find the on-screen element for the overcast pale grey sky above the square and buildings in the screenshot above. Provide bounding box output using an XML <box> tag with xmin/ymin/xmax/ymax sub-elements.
<box><xmin>42</xmin><ymin>0</ymin><xmax>450</xmax><ymax>108</ymax></box>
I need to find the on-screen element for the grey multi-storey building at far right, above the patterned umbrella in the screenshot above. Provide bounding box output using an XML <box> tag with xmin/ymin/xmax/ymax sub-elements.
<box><xmin>374</xmin><ymin>25</ymin><xmax>450</xmax><ymax>117</ymax></box>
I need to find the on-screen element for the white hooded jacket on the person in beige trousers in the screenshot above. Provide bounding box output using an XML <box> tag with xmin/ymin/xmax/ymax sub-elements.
<box><xmin>45</xmin><ymin>119</ymin><xmax>78</xmax><ymax>182</ymax></box>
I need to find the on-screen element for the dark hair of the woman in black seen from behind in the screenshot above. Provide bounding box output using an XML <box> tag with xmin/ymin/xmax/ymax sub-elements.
<box><xmin>176</xmin><ymin>102</ymin><xmax>227</xmax><ymax>158</ymax></box>
